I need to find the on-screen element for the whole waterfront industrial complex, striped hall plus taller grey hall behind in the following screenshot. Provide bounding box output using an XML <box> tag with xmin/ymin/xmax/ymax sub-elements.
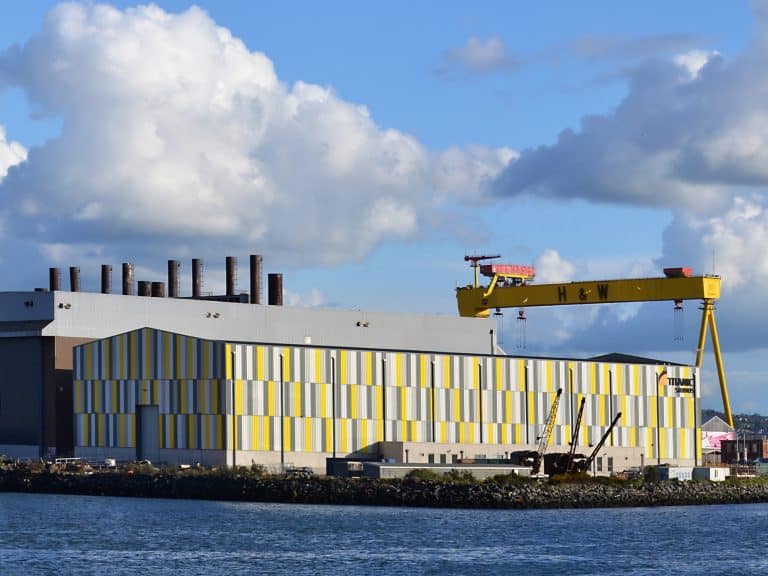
<box><xmin>0</xmin><ymin>259</ymin><xmax>701</xmax><ymax>473</ymax></box>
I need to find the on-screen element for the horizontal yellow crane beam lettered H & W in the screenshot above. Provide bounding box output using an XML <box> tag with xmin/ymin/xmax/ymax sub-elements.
<box><xmin>456</xmin><ymin>276</ymin><xmax>720</xmax><ymax>316</ymax></box>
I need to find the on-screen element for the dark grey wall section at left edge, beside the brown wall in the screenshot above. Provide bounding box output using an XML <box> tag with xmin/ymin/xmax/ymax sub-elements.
<box><xmin>0</xmin><ymin>338</ymin><xmax>43</xmax><ymax>446</ymax></box>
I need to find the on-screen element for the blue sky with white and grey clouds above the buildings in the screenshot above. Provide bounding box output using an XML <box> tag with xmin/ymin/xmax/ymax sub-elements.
<box><xmin>0</xmin><ymin>0</ymin><xmax>768</xmax><ymax>414</ymax></box>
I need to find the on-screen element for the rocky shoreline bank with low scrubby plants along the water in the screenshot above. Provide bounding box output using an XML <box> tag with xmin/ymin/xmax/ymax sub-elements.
<box><xmin>0</xmin><ymin>465</ymin><xmax>768</xmax><ymax>509</ymax></box>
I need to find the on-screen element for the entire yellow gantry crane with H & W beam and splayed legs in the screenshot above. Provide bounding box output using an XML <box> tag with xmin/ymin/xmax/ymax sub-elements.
<box><xmin>456</xmin><ymin>255</ymin><xmax>733</xmax><ymax>426</ymax></box>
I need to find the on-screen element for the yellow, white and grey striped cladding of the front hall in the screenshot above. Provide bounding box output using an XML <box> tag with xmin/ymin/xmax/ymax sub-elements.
<box><xmin>74</xmin><ymin>328</ymin><xmax>701</xmax><ymax>467</ymax></box>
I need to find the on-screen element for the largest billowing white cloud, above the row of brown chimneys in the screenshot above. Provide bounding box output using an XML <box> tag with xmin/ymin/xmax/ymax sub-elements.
<box><xmin>0</xmin><ymin>4</ymin><xmax>512</xmax><ymax>265</ymax></box>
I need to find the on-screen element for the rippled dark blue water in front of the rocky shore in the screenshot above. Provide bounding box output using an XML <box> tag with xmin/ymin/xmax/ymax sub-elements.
<box><xmin>0</xmin><ymin>494</ymin><xmax>768</xmax><ymax>576</ymax></box>
